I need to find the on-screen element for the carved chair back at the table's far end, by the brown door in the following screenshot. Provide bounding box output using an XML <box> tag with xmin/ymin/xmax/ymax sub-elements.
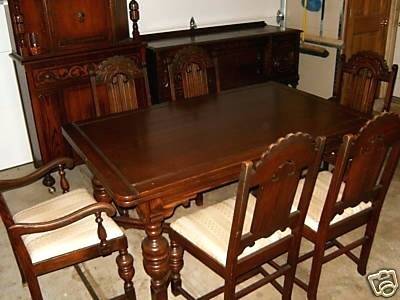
<box><xmin>333</xmin><ymin>51</ymin><xmax>398</xmax><ymax>114</ymax></box>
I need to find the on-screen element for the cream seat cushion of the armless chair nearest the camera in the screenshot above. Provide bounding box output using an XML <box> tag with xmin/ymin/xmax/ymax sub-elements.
<box><xmin>171</xmin><ymin>195</ymin><xmax>291</xmax><ymax>266</ymax></box>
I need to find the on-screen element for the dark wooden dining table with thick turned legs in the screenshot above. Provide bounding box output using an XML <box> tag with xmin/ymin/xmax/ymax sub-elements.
<box><xmin>62</xmin><ymin>82</ymin><xmax>367</xmax><ymax>299</ymax></box>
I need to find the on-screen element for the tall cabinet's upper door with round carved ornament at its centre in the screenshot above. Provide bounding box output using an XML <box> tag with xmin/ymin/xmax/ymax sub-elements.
<box><xmin>47</xmin><ymin>0</ymin><xmax>112</xmax><ymax>50</ymax></box>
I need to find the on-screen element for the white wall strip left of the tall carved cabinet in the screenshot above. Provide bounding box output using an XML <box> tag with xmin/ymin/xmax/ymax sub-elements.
<box><xmin>0</xmin><ymin>6</ymin><xmax>32</xmax><ymax>170</ymax></box>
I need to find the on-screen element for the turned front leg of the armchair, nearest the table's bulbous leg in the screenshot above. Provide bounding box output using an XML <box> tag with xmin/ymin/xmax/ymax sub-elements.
<box><xmin>116</xmin><ymin>249</ymin><xmax>136</xmax><ymax>300</ymax></box>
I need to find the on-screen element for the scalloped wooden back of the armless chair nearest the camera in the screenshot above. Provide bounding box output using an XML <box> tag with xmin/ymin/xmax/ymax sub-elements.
<box><xmin>227</xmin><ymin>133</ymin><xmax>325</xmax><ymax>267</ymax></box>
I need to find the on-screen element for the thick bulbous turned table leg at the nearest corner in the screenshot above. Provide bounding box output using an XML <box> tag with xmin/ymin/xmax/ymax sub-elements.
<box><xmin>142</xmin><ymin>221</ymin><xmax>169</xmax><ymax>300</ymax></box>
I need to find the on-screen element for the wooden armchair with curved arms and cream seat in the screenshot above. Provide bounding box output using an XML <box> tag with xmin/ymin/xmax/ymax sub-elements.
<box><xmin>0</xmin><ymin>158</ymin><xmax>136</xmax><ymax>300</ymax></box>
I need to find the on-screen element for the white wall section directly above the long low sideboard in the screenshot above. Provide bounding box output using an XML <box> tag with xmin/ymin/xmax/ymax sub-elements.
<box><xmin>137</xmin><ymin>0</ymin><xmax>280</xmax><ymax>34</ymax></box>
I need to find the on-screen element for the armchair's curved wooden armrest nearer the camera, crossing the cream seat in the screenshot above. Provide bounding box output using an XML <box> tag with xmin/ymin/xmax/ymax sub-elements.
<box><xmin>9</xmin><ymin>202</ymin><xmax>116</xmax><ymax>236</ymax></box>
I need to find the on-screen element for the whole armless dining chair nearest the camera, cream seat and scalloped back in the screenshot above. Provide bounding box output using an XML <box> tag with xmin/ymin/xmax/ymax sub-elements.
<box><xmin>170</xmin><ymin>133</ymin><xmax>325</xmax><ymax>299</ymax></box>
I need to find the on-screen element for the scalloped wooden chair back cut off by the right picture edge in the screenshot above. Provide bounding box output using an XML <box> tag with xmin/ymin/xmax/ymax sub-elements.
<box><xmin>321</xmin><ymin>113</ymin><xmax>400</xmax><ymax>226</ymax></box>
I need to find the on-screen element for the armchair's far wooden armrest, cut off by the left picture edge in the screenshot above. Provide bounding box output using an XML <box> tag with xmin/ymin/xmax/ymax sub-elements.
<box><xmin>0</xmin><ymin>157</ymin><xmax>74</xmax><ymax>192</ymax></box>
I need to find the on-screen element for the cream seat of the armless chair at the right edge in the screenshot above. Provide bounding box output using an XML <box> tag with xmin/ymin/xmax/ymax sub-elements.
<box><xmin>293</xmin><ymin>171</ymin><xmax>371</xmax><ymax>231</ymax></box>
